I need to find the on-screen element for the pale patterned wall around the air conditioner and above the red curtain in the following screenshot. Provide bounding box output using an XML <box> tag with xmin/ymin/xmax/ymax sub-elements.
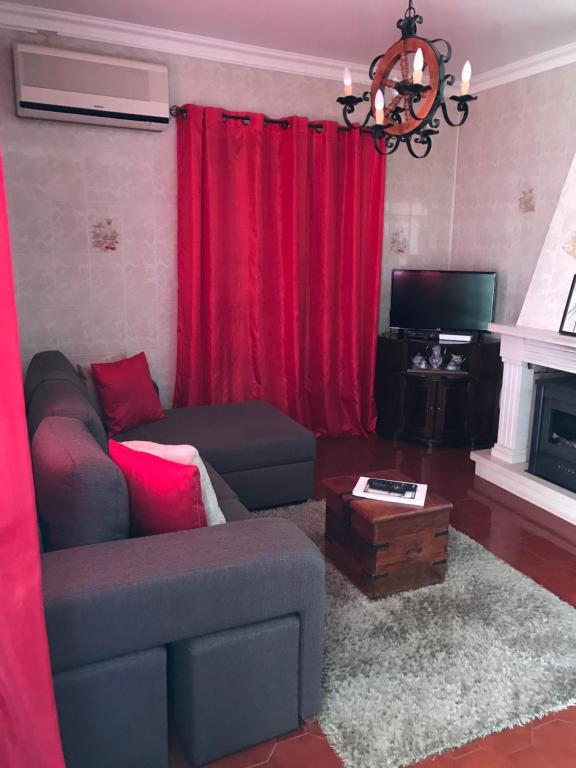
<box><xmin>0</xmin><ymin>30</ymin><xmax>340</xmax><ymax>403</ymax></box>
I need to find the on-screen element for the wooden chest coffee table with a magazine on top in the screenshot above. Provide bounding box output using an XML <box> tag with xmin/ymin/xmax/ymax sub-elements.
<box><xmin>324</xmin><ymin>470</ymin><xmax>452</xmax><ymax>598</ymax></box>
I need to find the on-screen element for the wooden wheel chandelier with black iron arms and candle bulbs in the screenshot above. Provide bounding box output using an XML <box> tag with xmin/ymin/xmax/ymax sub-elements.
<box><xmin>337</xmin><ymin>0</ymin><xmax>477</xmax><ymax>158</ymax></box>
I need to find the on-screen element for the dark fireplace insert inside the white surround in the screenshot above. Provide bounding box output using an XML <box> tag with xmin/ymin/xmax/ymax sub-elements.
<box><xmin>528</xmin><ymin>376</ymin><xmax>576</xmax><ymax>491</ymax></box>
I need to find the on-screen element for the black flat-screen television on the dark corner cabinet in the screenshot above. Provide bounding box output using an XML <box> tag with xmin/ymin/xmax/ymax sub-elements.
<box><xmin>390</xmin><ymin>269</ymin><xmax>496</xmax><ymax>331</ymax></box>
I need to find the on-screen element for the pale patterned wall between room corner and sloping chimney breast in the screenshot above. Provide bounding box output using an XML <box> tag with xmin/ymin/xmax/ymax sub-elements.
<box><xmin>451</xmin><ymin>64</ymin><xmax>576</xmax><ymax>323</ymax></box>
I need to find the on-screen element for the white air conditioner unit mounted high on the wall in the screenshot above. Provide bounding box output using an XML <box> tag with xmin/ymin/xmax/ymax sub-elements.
<box><xmin>14</xmin><ymin>43</ymin><xmax>170</xmax><ymax>131</ymax></box>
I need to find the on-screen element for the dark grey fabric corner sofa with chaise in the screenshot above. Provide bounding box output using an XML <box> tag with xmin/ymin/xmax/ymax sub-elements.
<box><xmin>25</xmin><ymin>352</ymin><xmax>324</xmax><ymax>768</ymax></box>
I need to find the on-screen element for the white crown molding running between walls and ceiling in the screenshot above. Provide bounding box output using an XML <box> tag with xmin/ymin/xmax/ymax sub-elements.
<box><xmin>0</xmin><ymin>0</ymin><xmax>576</xmax><ymax>93</ymax></box>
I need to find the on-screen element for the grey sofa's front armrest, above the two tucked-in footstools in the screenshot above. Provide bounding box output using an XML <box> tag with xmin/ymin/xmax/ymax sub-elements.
<box><xmin>42</xmin><ymin>518</ymin><xmax>324</xmax><ymax>710</ymax></box>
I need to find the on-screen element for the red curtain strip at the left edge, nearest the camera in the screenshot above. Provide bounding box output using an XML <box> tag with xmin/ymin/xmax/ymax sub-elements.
<box><xmin>0</xmin><ymin>147</ymin><xmax>64</xmax><ymax>768</ymax></box>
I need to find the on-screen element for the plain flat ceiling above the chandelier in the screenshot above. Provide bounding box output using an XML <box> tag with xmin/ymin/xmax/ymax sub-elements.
<box><xmin>3</xmin><ymin>0</ymin><xmax>576</xmax><ymax>74</ymax></box>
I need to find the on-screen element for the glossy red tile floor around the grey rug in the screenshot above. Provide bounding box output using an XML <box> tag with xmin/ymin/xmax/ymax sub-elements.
<box><xmin>172</xmin><ymin>437</ymin><xmax>576</xmax><ymax>768</ymax></box>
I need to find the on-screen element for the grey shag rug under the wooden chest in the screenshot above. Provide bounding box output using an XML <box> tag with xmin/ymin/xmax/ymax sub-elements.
<box><xmin>254</xmin><ymin>501</ymin><xmax>576</xmax><ymax>768</ymax></box>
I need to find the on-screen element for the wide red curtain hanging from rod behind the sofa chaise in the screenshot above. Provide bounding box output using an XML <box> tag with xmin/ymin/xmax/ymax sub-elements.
<box><xmin>174</xmin><ymin>105</ymin><xmax>384</xmax><ymax>435</ymax></box>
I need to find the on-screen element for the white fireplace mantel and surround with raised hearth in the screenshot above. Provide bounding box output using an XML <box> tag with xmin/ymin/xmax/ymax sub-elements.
<box><xmin>471</xmin><ymin>320</ymin><xmax>576</xmax><ymax>524</ymax></box>
